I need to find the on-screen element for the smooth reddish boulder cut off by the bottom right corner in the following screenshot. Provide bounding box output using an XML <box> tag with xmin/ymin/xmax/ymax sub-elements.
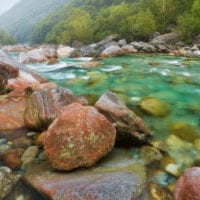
<box><xmin>174</xmin><ymin>167</ymin><xmax>200</xmax><ymax>200</ymax></box>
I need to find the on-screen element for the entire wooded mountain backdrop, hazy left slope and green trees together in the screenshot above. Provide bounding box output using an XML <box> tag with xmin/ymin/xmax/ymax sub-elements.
<box><xmin>0</xmin><ymin>0</ymin><xmax>200</xmax><ymax>44</ymax></box>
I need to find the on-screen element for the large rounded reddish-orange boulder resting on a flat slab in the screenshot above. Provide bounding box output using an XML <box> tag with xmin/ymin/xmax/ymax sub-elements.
<box><xmin>44</xmin><ymin>103</ymin><xmax>116</xmax><ymax>170</ymax></box>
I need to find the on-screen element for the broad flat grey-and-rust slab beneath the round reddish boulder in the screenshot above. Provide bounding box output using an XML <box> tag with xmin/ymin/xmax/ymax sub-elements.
<box><xmin>24</xmin><ymin>149</ymin><xmax>146</xmax><ymax>200</ymax></box>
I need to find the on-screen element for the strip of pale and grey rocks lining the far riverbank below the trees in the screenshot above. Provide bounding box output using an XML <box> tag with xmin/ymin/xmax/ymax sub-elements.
<box><xmin>2</xmin><ymin>32</ymin><xmax>200</xmax><ymax>64</ymax></box>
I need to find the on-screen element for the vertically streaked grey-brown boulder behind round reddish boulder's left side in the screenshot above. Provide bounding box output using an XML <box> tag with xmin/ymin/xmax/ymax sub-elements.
<box><xmin>24</xmin><ymin>87</ymin><xmax>87</xmax><ymax>130</ymax></box>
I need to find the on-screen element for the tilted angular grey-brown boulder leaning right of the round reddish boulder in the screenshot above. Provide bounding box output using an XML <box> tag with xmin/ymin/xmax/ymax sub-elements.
<box><xmin>95</xmin><ymin>91</ymin><xmax>151</xmax><ymax>142</ymax></box>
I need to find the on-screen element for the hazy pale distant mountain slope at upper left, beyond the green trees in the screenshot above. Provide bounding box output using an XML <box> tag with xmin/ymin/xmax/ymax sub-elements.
<box><xmin>0</xmin><ymin>0</ymin><xmax>69</xmax><ymax>42</ymax></box>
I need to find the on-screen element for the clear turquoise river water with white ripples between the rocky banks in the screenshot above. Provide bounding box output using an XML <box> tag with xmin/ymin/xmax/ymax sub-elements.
<box><xmin>29</xmin><ymin>55</ymin><xmax>200</xmax><ymax>139</ymax></box>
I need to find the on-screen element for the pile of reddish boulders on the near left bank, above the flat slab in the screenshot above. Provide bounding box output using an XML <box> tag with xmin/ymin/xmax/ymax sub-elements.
<box><xmin>0</xmin><ymin>53</ymin><xmax>151</xmax><ymax>167</ymax></box>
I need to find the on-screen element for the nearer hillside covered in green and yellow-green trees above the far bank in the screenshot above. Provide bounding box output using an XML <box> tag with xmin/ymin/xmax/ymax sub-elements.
<box><xmin>31</xmin><ymin>0</ymin><xmax>200</xmax><ymax>44</ymax></box>
